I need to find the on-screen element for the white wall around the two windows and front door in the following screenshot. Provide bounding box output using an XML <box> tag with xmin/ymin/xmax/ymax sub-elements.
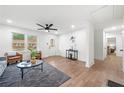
<box><xmin>0</xmin><ymin>24</ymin><xmax>58</xmax><ymax>57</ymax></box>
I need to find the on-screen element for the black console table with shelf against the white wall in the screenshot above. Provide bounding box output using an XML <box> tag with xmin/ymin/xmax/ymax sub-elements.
<box><xmin>66</xmin><ymin>49</ymin><xmax>78</xmax><ymax>60</ymax></box>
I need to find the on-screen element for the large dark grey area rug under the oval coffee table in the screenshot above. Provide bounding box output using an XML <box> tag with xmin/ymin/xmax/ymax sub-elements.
<box><xmin>0</xmin><ymin>63</ymin><xmax>70</xmax><ymax>87</ymax></box>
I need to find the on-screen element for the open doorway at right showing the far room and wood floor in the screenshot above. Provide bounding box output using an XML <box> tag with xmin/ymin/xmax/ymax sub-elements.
<box><xmin>103</xmin><ymin>30</ymin><xmax>124</xmax><ymax>71</ymax></box>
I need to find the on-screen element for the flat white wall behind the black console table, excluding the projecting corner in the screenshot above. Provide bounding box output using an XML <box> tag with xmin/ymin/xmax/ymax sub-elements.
<box><xmin>59</xmin><ymin>29</ymin><xmax>88</xmax><ymax>61</ymax></box>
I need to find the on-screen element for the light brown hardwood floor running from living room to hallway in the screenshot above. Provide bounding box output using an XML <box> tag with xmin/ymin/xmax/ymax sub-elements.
<box><xmin>46</xmin><ymin>55</ymin><xmax>124</xmax><ymax>87</ymax></box>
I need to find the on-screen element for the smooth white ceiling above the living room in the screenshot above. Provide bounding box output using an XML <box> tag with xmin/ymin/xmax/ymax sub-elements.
<box><xmin>0</xmin><ymin>5</ymin><xmax>124</xmax><ymax>34</ymax></box>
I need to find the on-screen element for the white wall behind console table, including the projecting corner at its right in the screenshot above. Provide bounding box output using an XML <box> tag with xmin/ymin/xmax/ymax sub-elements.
<box><xmin>59</xmin><ymin>24</ymin><xmax>94</xmax><ymax>67</ymax></box>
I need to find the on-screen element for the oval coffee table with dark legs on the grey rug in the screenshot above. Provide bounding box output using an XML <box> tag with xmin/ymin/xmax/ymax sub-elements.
<box><xmin>16</xmin><ymin>60</ymin><xmax>43</xmax><ymax>79</ymax></box>
